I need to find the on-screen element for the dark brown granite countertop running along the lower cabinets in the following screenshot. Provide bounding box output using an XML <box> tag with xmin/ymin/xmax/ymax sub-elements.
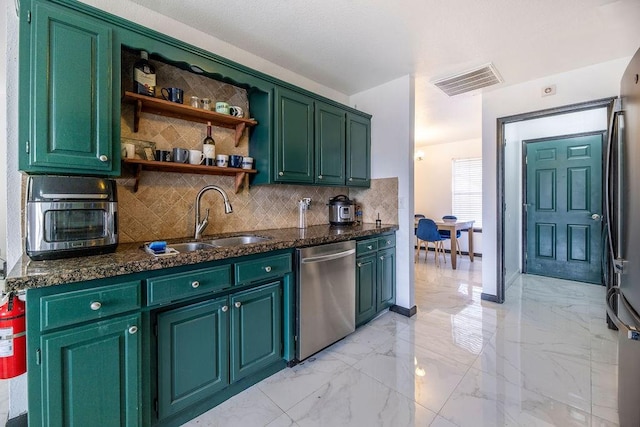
<box><xmin>6</xmin><ymin>224</ymin><xmax>398</xmax><ymax>291</ymax></box>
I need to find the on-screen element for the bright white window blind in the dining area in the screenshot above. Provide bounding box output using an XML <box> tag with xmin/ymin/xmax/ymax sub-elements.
<box><xmin>451</xmin><ymin>157</ymin><xmax>482</xmax><ymax>228</ymax></box>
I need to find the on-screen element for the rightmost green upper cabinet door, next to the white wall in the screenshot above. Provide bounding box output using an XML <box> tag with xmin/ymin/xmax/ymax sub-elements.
<box><xmin>346</xmin><ymin>113</ymin><xmax>371</xmax><ymax>187</ymax></box>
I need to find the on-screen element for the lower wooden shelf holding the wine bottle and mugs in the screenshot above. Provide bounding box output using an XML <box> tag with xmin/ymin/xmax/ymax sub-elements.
<box><xmin>122</xmin><ymin>159</ymin><xmax>258</xmax><ymax>194</ymax></box>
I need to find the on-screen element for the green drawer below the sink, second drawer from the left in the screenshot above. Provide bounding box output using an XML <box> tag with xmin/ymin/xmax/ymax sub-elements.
<box><xmin>147</xmin><ymin>265</ymin><xmax>233</xmax><ymax>305</ymax></box>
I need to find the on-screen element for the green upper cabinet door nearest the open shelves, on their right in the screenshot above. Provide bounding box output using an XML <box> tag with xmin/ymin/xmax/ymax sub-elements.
<box><xmin>274</xmin><ymin>87</ymin><xmax>314</xmax><ymax>184</ymax></box>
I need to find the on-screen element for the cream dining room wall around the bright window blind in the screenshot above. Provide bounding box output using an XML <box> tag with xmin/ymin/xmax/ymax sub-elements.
<box><xmin>414</xmin><ymin>138</ymin><xmax>482</xmax><ymax>253</ymax></box>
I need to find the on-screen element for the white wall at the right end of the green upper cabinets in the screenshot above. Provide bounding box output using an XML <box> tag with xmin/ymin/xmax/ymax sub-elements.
<box><xmin>351</xmin><ymin>76</ymin><xmax>415</xmax><ymax>308</ymax></box>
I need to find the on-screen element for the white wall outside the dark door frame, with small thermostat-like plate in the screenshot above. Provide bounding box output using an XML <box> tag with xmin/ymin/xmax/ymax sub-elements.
<box><xmin>482</xmin><ymin>57</ymin><xmax>631</xmax><ymax>295</ymax></box>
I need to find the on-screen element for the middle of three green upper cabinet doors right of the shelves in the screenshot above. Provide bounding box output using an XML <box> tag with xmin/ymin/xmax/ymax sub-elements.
<box><xmin>314</xmin><ymin>102</ymin><xmax>346</xmax><ymax>185</ymax></box>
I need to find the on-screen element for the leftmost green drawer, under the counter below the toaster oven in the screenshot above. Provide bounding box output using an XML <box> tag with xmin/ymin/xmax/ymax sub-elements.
<box><xmin>40</xmin><ymin>280</ymin><xmax>140</xmax><ymax>331</ymax></box>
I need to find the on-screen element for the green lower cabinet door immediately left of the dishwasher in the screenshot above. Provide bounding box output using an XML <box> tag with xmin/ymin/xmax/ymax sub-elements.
<box><xmin>230</xmin><ymin>281</ymin><xmax>282</xmax><ymax>382</ymax></box>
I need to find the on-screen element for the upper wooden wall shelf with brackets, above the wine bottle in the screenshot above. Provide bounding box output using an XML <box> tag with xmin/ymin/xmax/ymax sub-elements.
<box><xmin>123</xmin><ymin>92</ymin><xmax>258</xmax><ymax>147</ymax></box>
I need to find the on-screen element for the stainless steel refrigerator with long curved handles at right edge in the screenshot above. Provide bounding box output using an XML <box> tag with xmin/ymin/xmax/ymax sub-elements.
<box><xmin>605</xmin><ymin>50</ymin><xmax>640</xmax><ymax>427</ymax></box>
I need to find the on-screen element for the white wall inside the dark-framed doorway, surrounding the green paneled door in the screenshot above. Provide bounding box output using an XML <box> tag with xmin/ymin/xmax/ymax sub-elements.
<box><xmin>504</xmin><ymin>108</ymin><xmax>608</xmax><ymax>285</ymax></box>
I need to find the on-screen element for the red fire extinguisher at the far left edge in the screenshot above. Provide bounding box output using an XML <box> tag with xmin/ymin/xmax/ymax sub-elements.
<box><xmin>0</xmin><ymin>292</ymin><xmax>27</xmax><ymax>379</ymax></box>
